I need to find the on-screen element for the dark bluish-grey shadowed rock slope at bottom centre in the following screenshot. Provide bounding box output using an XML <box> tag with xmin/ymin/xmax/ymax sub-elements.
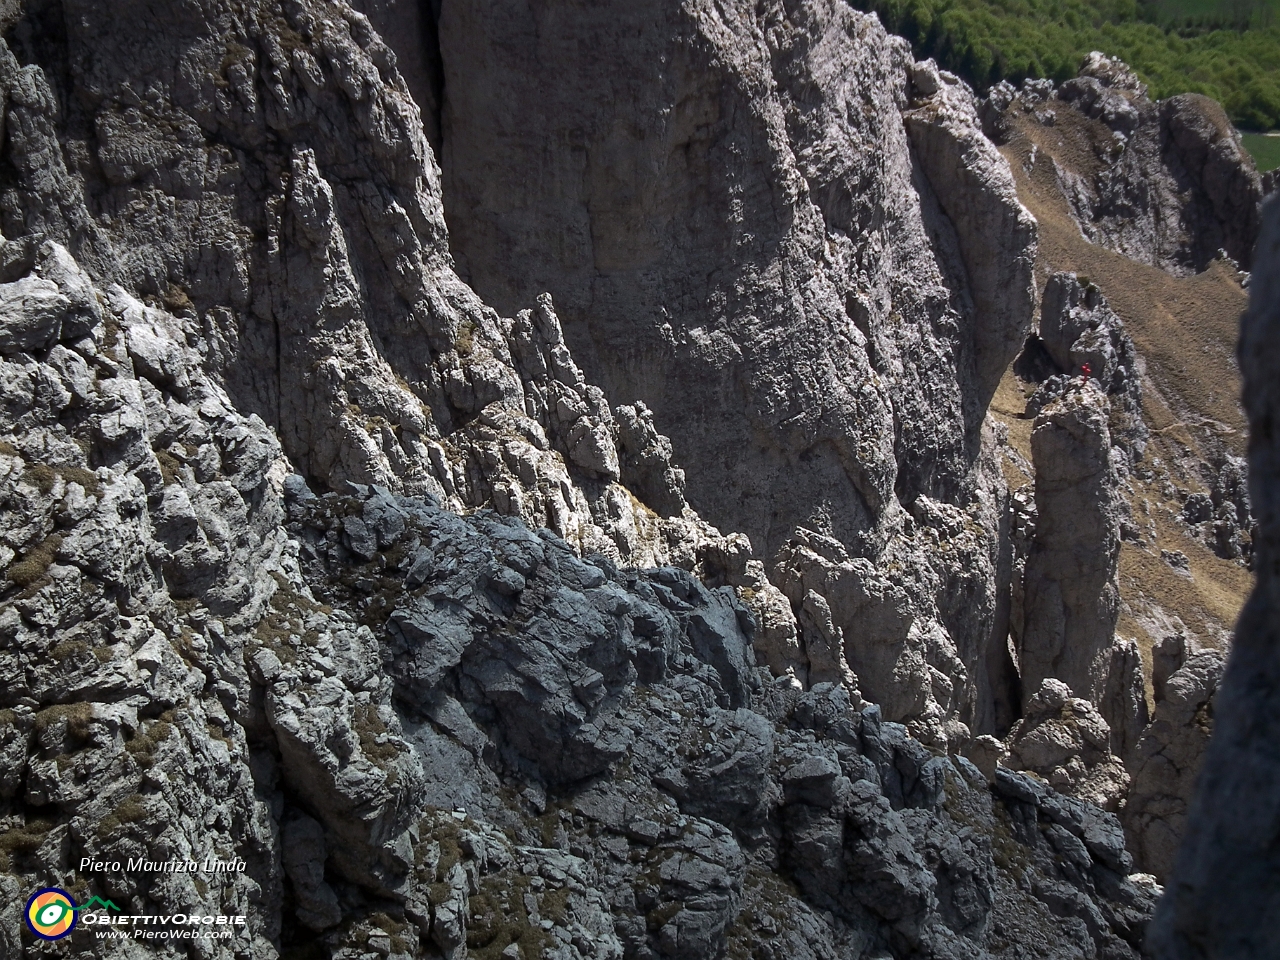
<box><xmin>285</xmin><ymin>479</ymin><xmax>1167</xmax><ymax>957</ymax></box>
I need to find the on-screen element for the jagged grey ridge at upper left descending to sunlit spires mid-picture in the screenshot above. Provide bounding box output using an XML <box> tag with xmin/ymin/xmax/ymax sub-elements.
<box><xmin>0</xmin><ymin>3</ymin><xmax>716</xmax><ymax>566</ymax></box>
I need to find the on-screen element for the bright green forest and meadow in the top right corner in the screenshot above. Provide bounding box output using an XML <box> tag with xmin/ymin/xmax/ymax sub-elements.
<box><xmin>855</xmin><ymin>0</ymin><xmax>1280</xmax><ymax>131</ymax></box>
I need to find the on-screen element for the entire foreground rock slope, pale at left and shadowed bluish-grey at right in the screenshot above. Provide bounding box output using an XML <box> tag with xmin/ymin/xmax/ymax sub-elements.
<box><xmin>0</xmin><ymin>241</ymin><xmax>1153</xmax><ymax>957</ymax></box>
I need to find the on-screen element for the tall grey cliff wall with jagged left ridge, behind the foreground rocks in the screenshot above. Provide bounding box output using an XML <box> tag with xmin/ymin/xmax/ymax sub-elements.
<box><xmin>0</xmin><ymin>1</ymin><xmax>1034</xmax><ymax>773</ymax></box>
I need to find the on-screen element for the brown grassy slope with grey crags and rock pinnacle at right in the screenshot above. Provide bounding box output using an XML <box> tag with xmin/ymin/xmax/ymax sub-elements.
<box><xmin>982</xmin><ymin>55</ymin><xmax>1257</xmax><ymax>896</ymax></box>
